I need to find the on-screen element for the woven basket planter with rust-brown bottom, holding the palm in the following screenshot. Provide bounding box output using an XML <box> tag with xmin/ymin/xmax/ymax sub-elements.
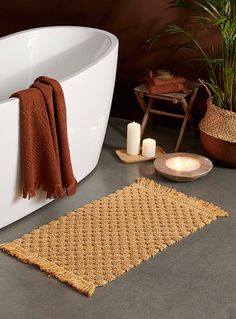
<box><xmin>199</xmin><ymin>96</ymin><xmax>236</xmax><ymax>167</ymax></box>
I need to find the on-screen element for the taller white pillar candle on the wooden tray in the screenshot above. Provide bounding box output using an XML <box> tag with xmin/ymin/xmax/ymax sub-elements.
<box><xmin>126</xmin><ymin>122</ymin><xmax>141</xmax><ymax>155</ymax></box>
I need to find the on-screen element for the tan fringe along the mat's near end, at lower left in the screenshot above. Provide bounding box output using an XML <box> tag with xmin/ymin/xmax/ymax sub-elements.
<box><xmin>0</xmin><ymin>243</ymin><xmax>96</xmax><ymax>297</ymax></box>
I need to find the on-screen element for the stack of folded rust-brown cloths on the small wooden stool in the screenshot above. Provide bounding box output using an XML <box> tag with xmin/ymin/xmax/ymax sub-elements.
<box><xmin>144</xmin><ymin>71</ymin><xmax>187</xmax><ymax>94</ymax></box>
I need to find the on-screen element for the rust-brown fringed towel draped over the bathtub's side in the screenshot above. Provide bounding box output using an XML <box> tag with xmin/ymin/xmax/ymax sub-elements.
<box><xmin>11</xmin><ymin>76</ymin><xmax>76</xmax><ymax>198</ymax></box>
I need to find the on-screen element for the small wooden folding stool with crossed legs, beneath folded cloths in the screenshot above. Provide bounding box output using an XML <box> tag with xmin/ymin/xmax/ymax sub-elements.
<box><xmin>134</xmin><ymin>82</ymin><xmax>200</xmax><ymax>152</ymax></box>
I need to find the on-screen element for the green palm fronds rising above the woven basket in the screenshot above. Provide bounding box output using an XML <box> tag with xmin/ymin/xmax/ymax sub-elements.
<box><xmin>149</xmin><ymin>0</ymin><xmax>236</xmax><ymax>112</ymax></box>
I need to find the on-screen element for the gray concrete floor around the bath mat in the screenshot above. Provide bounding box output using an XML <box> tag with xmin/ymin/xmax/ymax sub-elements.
<box><xmin>0</xmin><ymin>118</ymin><xmax>236</xmax><ymax>319</ymax></box>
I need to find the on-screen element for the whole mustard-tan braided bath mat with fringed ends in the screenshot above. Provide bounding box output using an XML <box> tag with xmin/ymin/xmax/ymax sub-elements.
<box><xmin>0</xmin><ymin>178</ymin><xmax>228</xmax><ymax>296</ymax></box>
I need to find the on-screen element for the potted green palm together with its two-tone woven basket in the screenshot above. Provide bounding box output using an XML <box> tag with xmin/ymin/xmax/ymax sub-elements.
<box><xmin>150</xmin><ymin>0</ymin><xmax>236</xmax><ymax>167</ymax></box>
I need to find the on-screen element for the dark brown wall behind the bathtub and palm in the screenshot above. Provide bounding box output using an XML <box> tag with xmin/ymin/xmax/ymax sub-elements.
<box><xmin>0</xmin><ymin>0</ymin><xmax>218</xmax><ymax>125</ymax></box>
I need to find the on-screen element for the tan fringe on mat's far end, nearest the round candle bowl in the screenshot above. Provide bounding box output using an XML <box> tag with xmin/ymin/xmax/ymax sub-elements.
<box><xmin>136</xmin><ymin>177</ymin><xmax>229</xmax><ymax>217</ymax></box>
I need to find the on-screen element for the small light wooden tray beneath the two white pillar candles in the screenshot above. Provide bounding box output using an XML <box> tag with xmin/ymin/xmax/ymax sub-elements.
<box><xmin>115</xmin><ymin>146</ymin><xmax>165</xmax><ymax>164</ymax></box>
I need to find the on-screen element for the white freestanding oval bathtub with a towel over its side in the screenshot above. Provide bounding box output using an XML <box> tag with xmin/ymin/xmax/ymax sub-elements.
<box><xmin>0</xmin><ymin>26</ymin><xmax>118</xmax><ymax>228</ymax></box>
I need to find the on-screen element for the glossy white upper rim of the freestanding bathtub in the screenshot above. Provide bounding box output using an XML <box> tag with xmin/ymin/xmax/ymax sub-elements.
<box><xmin>0</xmin><ymin>25</ymin><xmax>119</xmax><ymax>107</ymax></box>
